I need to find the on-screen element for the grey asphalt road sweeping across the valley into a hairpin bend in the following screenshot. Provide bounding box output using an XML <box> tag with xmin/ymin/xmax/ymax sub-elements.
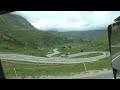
<box><xmin>0</xmin><ymin>51</ymin><xmax>110</xmax><ymax>63</ymax></box>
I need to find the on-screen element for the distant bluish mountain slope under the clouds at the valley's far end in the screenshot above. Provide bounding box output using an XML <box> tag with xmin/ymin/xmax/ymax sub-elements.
<box><xmin>47</xmin><ymin>29</ymin><xmax>106</xmax><ymax>42</ymax></box>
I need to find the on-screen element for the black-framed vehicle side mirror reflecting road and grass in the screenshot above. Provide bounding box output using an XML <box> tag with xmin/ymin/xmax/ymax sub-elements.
<box><xmin>108</xmin><ymin>22</ymin><xmax>120</xmax><ymax>79</ymax></box>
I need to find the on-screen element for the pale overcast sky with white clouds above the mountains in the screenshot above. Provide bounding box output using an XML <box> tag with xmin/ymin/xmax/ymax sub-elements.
<box><xmin>11</xmin><ymin>11</ymin><xmax>120</xmax><ymax>31</ymax></box>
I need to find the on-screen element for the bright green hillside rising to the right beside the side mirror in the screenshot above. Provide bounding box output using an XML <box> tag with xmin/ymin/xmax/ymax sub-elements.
<box><xmin>53</xmin><ymin>31</ymin><xmax>109</xmax><ymax>57</ymax></box>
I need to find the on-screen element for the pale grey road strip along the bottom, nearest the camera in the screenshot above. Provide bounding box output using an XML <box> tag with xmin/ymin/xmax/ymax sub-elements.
<box><xmin>9</xmin><ymin>69</ymin><xmax>113</xmax><ymax>79</ymax></box>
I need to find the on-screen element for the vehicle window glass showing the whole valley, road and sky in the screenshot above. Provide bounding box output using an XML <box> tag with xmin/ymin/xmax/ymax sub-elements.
<box><xmin>0</xmin><ymin>11</ymin><xmax>120</xmax><ymax>79</ymax></box>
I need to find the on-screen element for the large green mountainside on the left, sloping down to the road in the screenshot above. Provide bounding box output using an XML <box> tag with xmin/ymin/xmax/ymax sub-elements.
<box><xmin>0</xmin><ymin>14</ymin><xmax>69</xmax><ymax>56</ymax></box>
